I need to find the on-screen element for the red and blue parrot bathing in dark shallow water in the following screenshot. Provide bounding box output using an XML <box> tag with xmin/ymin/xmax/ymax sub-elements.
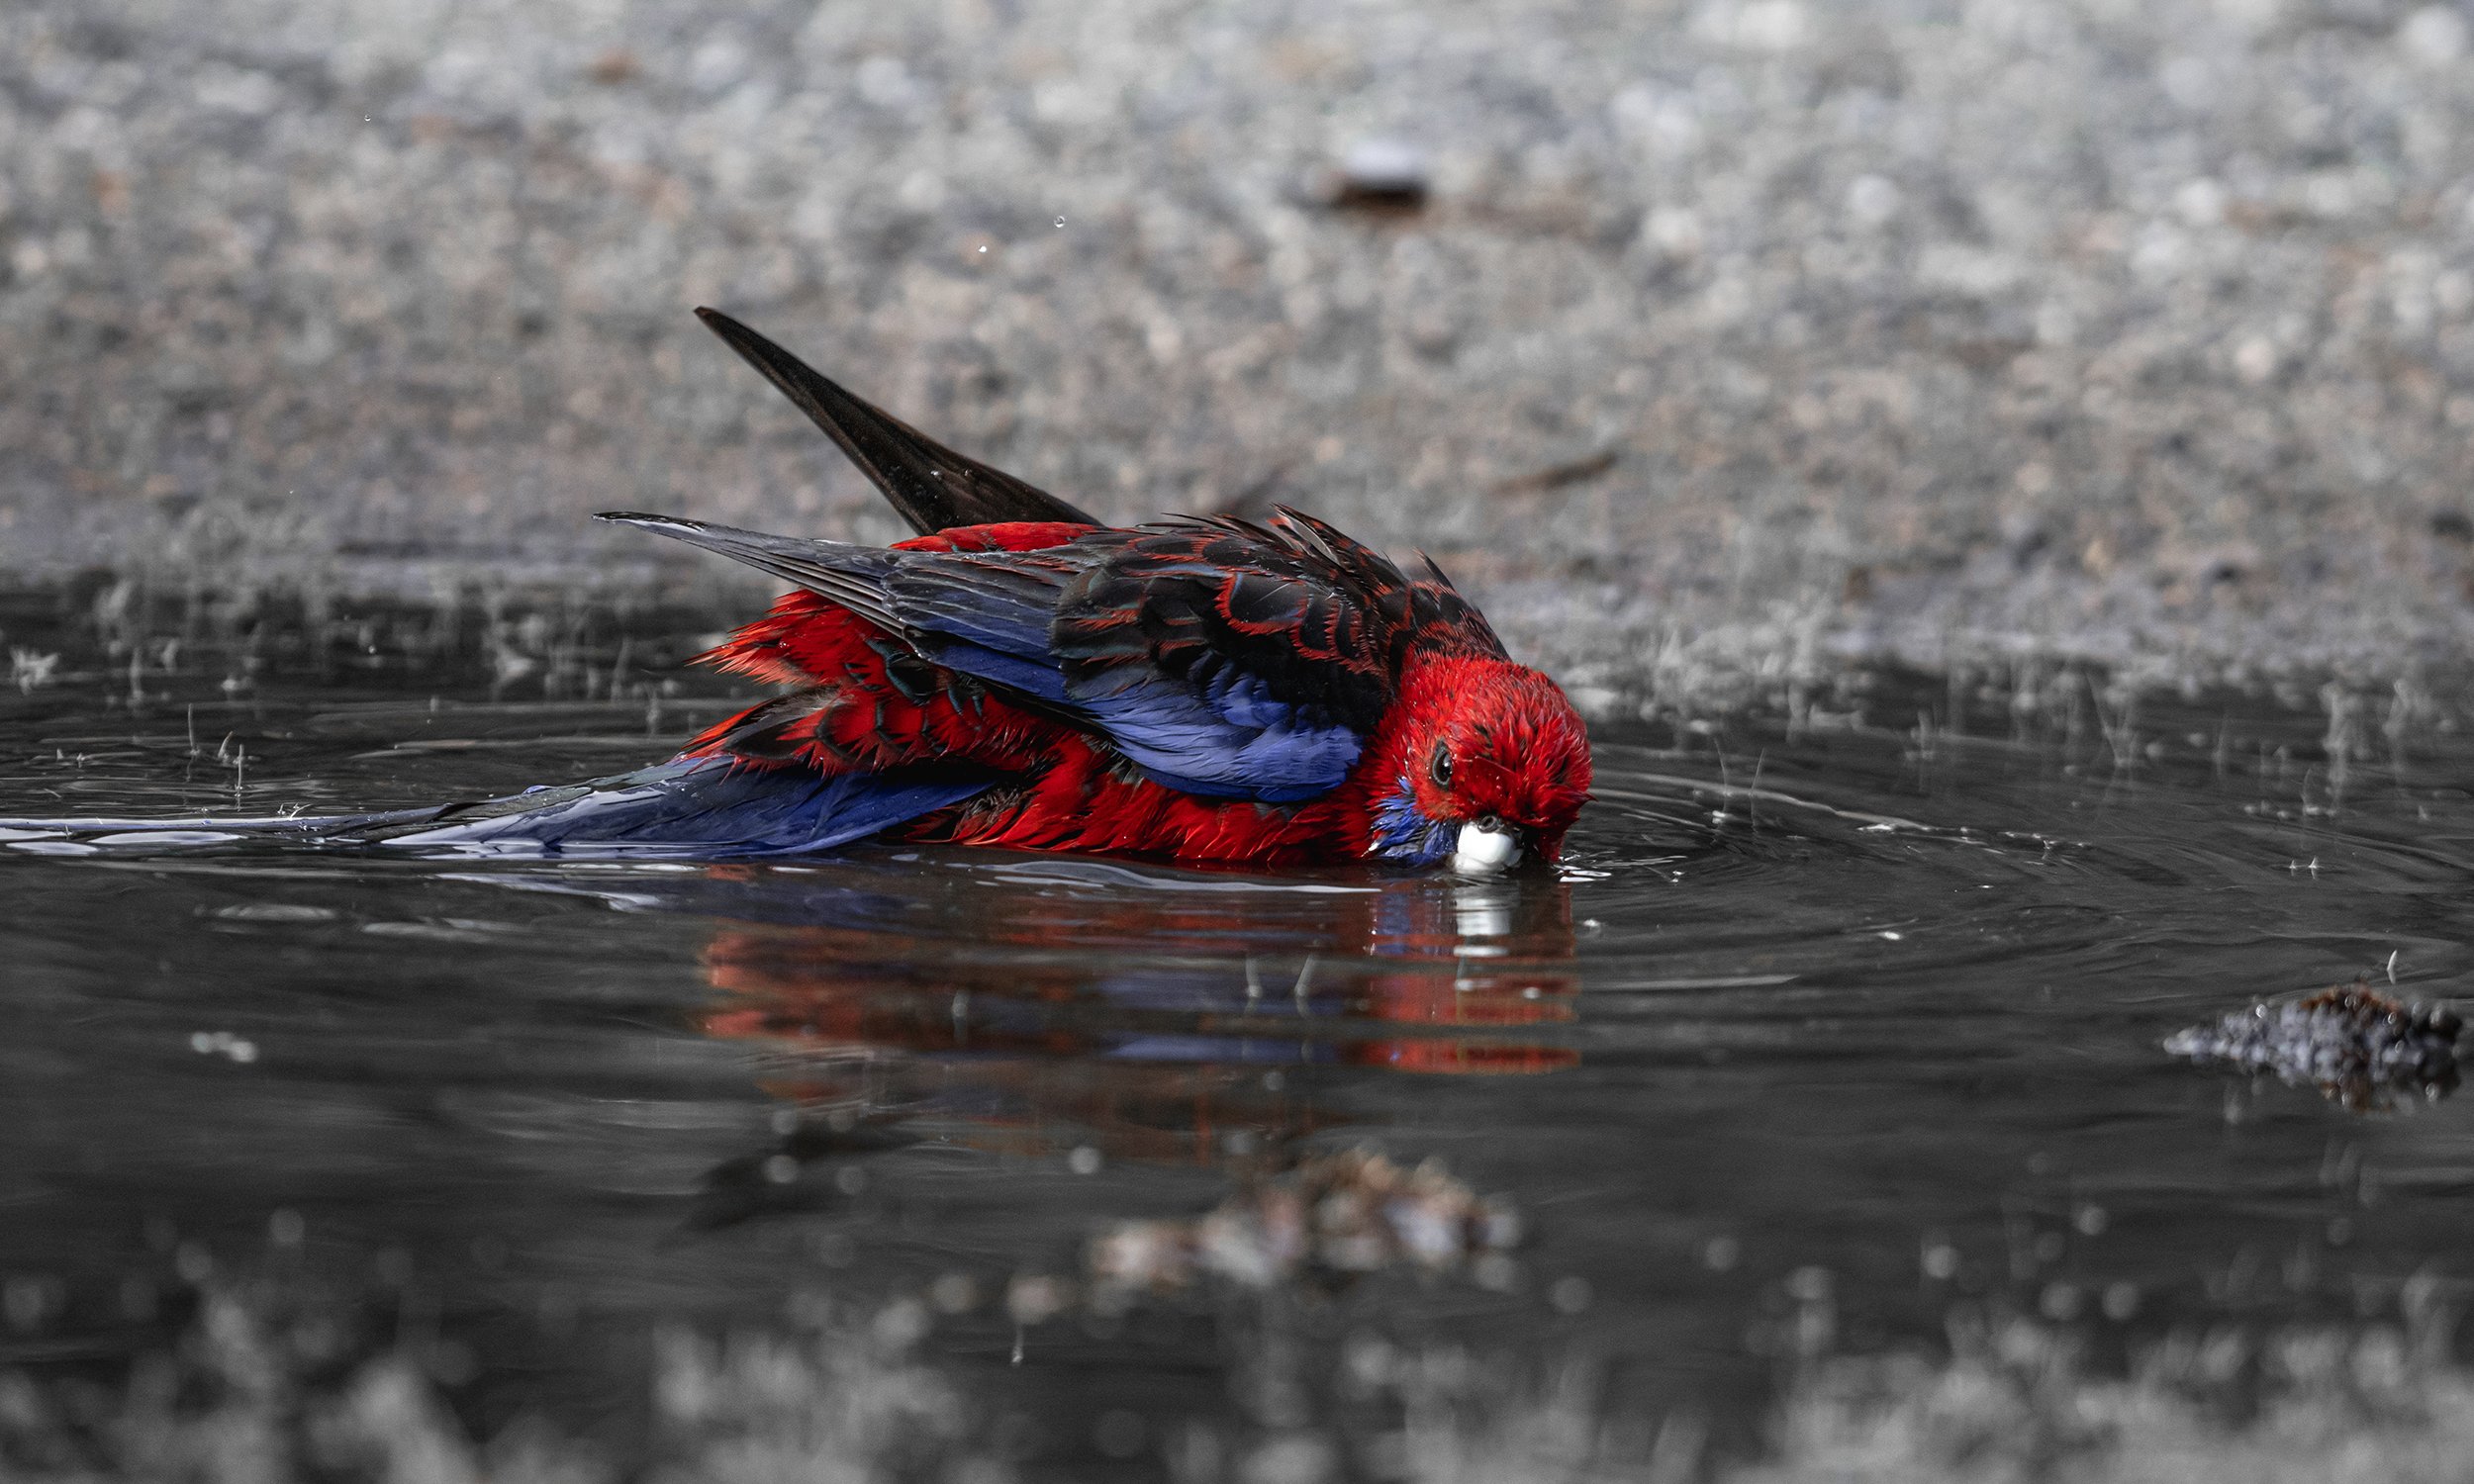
<box><xmin>391</xmin><ymin>310</ymin><xmax>1591</xmax><ymax>874</ymax></box>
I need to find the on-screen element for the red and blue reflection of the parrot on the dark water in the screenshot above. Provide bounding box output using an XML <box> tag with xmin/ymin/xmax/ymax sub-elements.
<box><xmin>643</xmin><ymin>861</ymin><xmax>1578</xmax><ymax>1162</ymax></box>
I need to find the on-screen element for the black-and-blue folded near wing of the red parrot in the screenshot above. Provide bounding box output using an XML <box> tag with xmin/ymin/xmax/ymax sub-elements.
<box><xmin>607</xmin><ymin>510</ymin><xmax>1502</xmax><ymax>804</ymax></box>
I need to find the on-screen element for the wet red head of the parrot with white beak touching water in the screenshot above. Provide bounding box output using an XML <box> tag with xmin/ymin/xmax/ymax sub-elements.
<box><xmin>1390</xmin><ymin>656</ymin><xmax>1591</xmax><ymax>874</ymax></box>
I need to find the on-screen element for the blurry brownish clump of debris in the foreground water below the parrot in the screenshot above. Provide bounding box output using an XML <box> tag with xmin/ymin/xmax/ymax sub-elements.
<box><xmin>1089</xmin><ymin>1151</ymin><xmax>1522</xmax><ymax>1294</ymax></box>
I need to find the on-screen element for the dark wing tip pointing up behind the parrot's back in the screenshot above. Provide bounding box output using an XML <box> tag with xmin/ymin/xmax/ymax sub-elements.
<box><xmin>696</xmin><ymin>310</ymin><xmax>1098</xmax><ymax>537</ymax></box>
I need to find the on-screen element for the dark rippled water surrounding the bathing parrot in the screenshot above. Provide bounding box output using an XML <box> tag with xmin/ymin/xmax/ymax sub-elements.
<box><xmin>0</xmin><ymin>599</ymin><xmax>2474</xmax><ymax>1477</ymax></box>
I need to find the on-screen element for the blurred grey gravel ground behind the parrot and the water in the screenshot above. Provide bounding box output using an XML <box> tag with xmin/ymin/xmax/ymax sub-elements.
<box><xmin>0</xmin><ymin>0</ymin><xmax>2474</xmax><ymax>710</ymax></box>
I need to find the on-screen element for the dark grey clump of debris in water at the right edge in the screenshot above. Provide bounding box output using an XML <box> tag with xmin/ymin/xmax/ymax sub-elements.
<box><xmin>2165</xmin><ymin>979</ymin><xmax>2464</xmax><ymax>1113</ymax></box>
